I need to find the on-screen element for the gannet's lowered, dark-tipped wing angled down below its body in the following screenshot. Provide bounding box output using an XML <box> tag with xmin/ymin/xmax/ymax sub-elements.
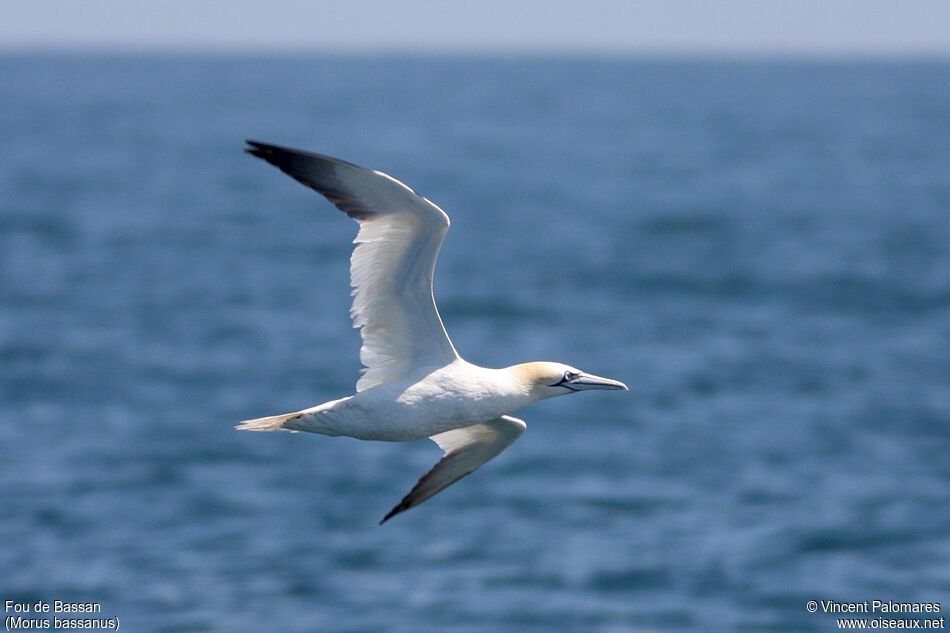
<box><xmin>379</xmin><ymin>415</ymin><xmax>527</xmax><ymax>525</ymax></box>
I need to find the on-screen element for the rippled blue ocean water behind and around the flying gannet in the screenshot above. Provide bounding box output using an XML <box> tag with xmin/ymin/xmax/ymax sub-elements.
<box><xmin>0</xmin><ymin>55</ymin><xmax>950</xmax><ymax>633</ymax></box>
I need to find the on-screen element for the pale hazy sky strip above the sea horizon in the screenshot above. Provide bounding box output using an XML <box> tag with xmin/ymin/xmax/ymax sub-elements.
<box><xmin>0</xmin><ymin>0</ymin><xmax>950</xmax><ymax>56</ymax></box>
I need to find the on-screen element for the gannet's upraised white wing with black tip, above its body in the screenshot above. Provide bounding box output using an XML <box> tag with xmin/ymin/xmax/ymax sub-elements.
<box><xmin>245</xmin><ymin>141</ymin><xmax>458</xmax><ymax>391</ymax></box>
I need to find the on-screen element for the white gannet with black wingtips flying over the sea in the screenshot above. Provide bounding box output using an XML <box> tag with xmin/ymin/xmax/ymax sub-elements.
<box><xmin>236</xmin><ymin>141</ymin><xmax>627</xmax><ymax>524</ymax></box>
